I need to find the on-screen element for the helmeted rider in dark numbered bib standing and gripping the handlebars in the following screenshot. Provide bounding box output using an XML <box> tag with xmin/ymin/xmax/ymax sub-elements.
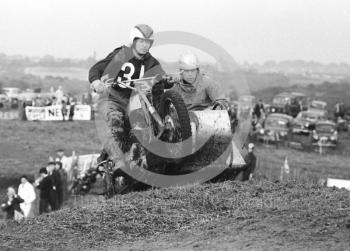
<box><xmin>89</xmin><ymin>24</ymin><xmax>164</xmax><ymax>168</ymax></box>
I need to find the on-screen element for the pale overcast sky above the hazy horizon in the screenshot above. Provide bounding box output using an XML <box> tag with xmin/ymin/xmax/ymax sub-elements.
<box><xmin>0</xmin><ymin>0</ymin><xmax>350</xmax><ymax>63</ymax></box>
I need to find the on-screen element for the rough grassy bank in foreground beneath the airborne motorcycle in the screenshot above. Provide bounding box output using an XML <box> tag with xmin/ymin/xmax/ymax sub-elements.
<box><xmin>0</xmin><ymin>181</ymin><xmax>350</xmax><ymax>250</ymax></box>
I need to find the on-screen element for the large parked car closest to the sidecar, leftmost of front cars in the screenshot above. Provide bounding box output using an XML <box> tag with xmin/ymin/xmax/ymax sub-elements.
<box><xmin>256</xmin><ymin>113</ymin><xmax>293</xmax><ymax>142</ymax></box>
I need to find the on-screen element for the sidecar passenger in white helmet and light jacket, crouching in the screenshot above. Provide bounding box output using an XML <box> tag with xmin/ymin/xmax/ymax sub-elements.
<box><xmin>172</xmin><ymin>53</ymin><xmax>228</xmax><ymax>110</ymax></box>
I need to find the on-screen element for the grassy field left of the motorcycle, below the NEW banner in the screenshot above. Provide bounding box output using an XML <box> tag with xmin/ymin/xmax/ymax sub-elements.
<box><xmin>0</xmin><ymin>121</ymin><xmax>101</xmax><ymax>176</ymax></box>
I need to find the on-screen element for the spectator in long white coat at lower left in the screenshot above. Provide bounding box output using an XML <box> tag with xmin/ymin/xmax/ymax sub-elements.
<box><xmin>18</xmin><ymin>175</ymin><xmax>36</xmax><ymax>218</ymax></box>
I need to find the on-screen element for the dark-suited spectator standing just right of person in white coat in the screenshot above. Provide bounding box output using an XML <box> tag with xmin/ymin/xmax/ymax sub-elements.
<box><xmin>35</xmin><ymin>167</ymin><xmax>52</xmax><ymax>214</ymax></box>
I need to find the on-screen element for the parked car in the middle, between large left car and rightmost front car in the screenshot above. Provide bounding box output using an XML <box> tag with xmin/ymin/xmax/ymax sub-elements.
<box><xmin>292</xmin><ymin>109</ymin><xmax>328</xmax><ymax>134</ymax></box>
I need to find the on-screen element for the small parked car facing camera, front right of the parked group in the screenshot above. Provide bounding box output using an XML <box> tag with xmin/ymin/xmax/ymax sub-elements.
<box><xmin>312</xmin><ymin>120</ymin><xmax>338</xmax><ymax>148</ymax></box>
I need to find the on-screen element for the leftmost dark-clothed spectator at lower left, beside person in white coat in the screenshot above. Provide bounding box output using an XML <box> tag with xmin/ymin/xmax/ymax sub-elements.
<box><xmin>1</xmin><ymin>187</ymin><xmax>24</xmax><ymax>221</ymax></box>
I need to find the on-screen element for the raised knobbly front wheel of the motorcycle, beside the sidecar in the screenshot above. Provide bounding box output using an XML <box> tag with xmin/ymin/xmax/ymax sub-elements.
<box><xmin>159</xmin><ymin>90</ymin><xmax>192</xmax><ymax>160</ymax></box>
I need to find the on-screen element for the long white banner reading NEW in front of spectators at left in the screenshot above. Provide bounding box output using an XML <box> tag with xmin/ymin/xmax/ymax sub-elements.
<box><xmin>25</xmin><ymin>105</ymin><xmax>91</xmax><ymax>121</ymax></box>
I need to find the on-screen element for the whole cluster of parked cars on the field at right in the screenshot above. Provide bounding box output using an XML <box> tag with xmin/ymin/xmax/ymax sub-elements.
<box><xmin>252</xmin><ymin>93</ymin><xmax>350</xmax><ymax>148</ymax></box>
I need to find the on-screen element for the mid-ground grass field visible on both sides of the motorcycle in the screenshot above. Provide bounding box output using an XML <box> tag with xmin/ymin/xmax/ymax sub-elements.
<box><xmin>0</xmin><ymin>121</ymin><xmax>350</xmax><ymax>182</ymax></box>
